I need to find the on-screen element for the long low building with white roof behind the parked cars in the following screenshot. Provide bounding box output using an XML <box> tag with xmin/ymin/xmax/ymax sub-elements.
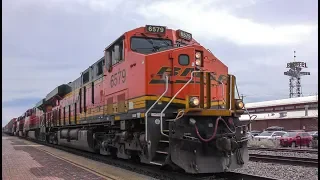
<box><xmin>240</xmin><ymin>95</ymin><xmax>318</xmax><ymax>131</ymax></box>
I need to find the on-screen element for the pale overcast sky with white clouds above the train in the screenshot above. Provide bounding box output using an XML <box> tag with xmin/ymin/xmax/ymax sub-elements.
<box><xmin>2</xmin><ymin>0</ymin><xmax>318</xmax><ymax>124</ymax></box>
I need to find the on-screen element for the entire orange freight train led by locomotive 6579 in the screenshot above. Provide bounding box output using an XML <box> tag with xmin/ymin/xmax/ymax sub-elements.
<box><xmin>5</xmin><ymin>25</ymin><xmax>249</xmax><ymax>174</ymax></box>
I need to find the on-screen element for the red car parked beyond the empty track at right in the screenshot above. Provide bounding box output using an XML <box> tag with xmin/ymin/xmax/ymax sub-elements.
<box><xmin>280</xmin><ymin>132</ymin><xmax>312</xmax><ymax>147</ymax></box>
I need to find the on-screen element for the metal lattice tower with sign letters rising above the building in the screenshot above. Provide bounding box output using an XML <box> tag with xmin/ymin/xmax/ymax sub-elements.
<box><xmin>284</xmin><ymin>51</ymin><xmax>310</xmax><ymax>98</ymax></box>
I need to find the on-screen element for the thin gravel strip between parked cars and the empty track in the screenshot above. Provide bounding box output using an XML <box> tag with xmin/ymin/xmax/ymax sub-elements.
<box><xmin>249</xmin><ymin>150</ymin><xmax>318</xmax><ymax>159</ymax></box>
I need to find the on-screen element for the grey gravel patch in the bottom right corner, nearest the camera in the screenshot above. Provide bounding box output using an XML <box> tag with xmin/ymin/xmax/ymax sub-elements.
<box><xmin>233</xmin><ymin>161</ymin><xmax>318</xmax><ymax>180</ymax></box>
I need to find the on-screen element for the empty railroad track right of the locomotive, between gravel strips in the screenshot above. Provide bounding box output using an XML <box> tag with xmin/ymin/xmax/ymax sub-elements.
<box><xmin>249</xmin><ymin>154</ymin><xmax>318</xmax><ymax>167</ymax></box>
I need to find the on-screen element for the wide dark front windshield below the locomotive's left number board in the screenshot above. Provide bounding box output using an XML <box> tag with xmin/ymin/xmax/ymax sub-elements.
<box><xmin>131</xmin><ymin>37</ymin><xmax>172</xmax><ymax>54</ymax></box>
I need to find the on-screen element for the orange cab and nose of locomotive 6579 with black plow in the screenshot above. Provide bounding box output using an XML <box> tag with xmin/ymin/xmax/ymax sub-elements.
<box><xmin>105</xmin><ymin>25</ymin><xmax>248</xmax><ymax>173</ymax></box>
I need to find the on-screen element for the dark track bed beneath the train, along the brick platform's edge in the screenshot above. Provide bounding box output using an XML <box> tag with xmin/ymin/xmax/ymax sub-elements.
<box><xmin>5</xmin><ymin>137</ymin><xmax>276</xmax><ymax>180</ymax></box>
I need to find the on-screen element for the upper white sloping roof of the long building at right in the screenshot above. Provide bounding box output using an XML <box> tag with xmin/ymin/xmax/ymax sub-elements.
<box><xmin>245</xmin><ymin>95</ymin><xmax>318</xmax><ymax>108</ymax></box>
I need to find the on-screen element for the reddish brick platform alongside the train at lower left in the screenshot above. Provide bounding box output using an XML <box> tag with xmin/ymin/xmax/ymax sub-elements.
<box><xmin>2</xmin><ymin>135</ymin><xmax>153</xmax><ymax>180</ymax></box>
